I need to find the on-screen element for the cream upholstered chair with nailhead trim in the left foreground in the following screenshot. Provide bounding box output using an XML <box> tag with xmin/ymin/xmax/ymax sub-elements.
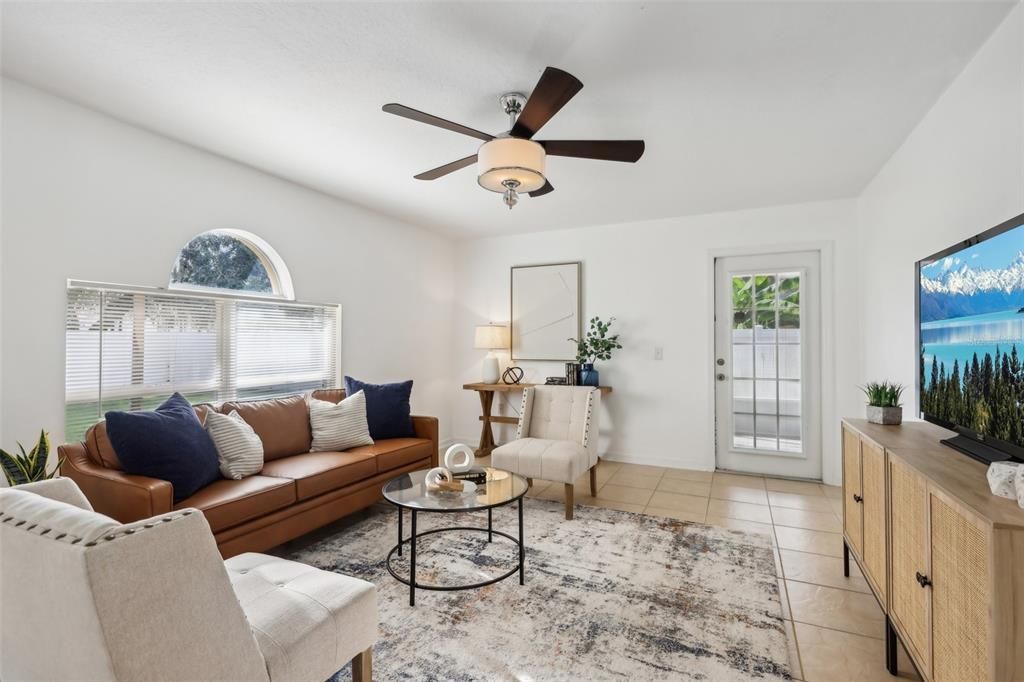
<box><xmin>0</xmin><ymin>478</ymin><xmax>378</xmax><ymax>682</ymax></box>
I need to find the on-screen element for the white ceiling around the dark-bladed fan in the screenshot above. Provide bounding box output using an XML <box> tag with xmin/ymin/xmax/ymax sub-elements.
<box><xmin>2</xmin><ymin>1</ymin><xmax>1014</xmax><ymax>236</ymax></box>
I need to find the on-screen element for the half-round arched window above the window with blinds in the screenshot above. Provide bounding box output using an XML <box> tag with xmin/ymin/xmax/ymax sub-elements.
<box><xmin>169</xmin><ymin>229</ymin><xmax>295</xmax><ymax>300</ymax></box>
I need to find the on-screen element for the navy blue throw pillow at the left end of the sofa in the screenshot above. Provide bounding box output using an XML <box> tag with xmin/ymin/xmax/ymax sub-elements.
<box><xmin>106</xmin><ymin>393</ymin><xmax>220</xmax><ymax>502</ymax></box>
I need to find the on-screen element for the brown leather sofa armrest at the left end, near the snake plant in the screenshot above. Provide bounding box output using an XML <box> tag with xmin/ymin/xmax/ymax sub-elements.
<box><xmin>57</xmin><ymin>443</ymin><xmax>174</xmax><ymax>523</ymax></box>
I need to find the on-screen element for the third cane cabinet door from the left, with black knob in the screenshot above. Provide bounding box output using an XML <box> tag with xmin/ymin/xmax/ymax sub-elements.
<box><xmin>889</xmin><ymin>450</ymin><xmax>931</xmax><ymax>676</ymax></box>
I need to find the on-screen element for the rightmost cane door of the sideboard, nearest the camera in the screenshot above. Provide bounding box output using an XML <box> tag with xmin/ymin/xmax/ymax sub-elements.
<box><xmin>929</xmin><ymin>494</ymin><xmax>992</xmax><ymax>682</ymax></box>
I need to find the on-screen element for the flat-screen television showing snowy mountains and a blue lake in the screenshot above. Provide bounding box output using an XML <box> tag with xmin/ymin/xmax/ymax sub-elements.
<box><xmin>916</xmin><ymin>214</ymin><xmax>1024</xmax><ymax>463</ymax></box>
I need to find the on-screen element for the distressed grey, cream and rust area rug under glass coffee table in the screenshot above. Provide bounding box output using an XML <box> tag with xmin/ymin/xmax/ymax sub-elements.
<box><xmin>286</xmin><ymin>499</ymin><xmax>791</xmax><ymax>682</ymax></box>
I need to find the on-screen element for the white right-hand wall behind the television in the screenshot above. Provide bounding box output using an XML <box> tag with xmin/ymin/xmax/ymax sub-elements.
<box><xmin>857</xmin><ymin>5</ymin><xmax>1024</xmax><ymax>415</ymax></box>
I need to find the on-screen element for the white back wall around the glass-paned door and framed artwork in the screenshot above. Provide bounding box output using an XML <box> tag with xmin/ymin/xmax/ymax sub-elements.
<box><xmin>453</xmin><ymin>197</ymin><xmax>861</xmax><ymax>482</ymax></box>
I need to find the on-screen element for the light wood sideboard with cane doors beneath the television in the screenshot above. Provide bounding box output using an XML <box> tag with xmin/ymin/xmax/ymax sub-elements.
<box><xmin>843</xmin><ymin>419</ymin><xmax>1024</xmax><ymax>682</ymax></box>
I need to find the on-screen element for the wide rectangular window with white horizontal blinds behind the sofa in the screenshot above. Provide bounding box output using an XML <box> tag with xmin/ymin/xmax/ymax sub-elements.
<box><xmin>65</xmin><ymin>282</ymin><xmax>341</xmax><ymax>441</ymax></box>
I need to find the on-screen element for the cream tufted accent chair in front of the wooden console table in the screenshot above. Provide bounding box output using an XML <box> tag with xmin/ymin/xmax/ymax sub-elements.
<box><xmin>490</xmin><ymin>386</ymin><xmax>601</xmax><ymax>520</ymax></box>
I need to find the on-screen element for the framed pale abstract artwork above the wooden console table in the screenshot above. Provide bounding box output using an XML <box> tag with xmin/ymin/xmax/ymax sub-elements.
<box><xmin>510</xmin><ymin>262</ymin><xmax>582</xmax><ymax>360</ymax></box>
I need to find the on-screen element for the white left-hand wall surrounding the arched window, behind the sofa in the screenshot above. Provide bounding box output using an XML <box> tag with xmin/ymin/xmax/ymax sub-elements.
<box><xmin>0</xmin><ymin>79</ymin><xmax>453</xmax><ymax>447</ymax></box>
